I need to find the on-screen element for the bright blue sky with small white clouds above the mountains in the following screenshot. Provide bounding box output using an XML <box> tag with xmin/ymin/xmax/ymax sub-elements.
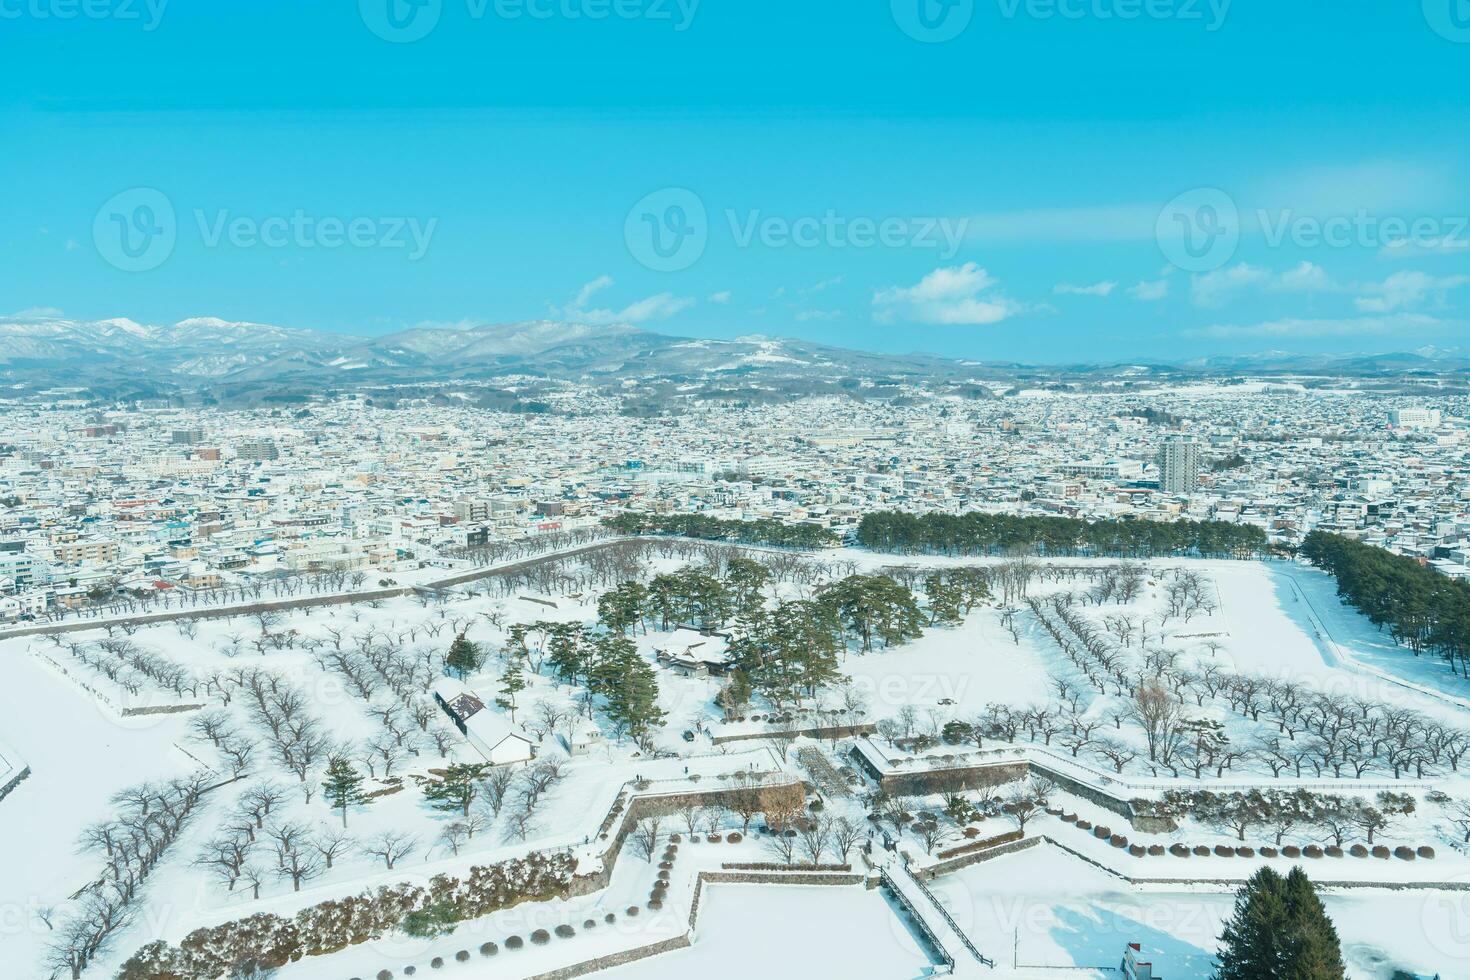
<box><xmin>0</xmin><ymin>0</ymin><xmax>1470</xmax><ymax>361</ymax></box>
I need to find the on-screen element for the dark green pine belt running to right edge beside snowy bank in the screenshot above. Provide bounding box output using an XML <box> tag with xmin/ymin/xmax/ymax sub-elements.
<box><xmin>1301</xmin><ymin>530</ymin><xmax>1470</xmax><ymax>677</ymax></box>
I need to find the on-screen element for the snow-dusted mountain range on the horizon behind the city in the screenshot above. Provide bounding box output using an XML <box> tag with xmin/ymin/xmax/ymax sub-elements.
<box><xmin>0</xmin><ymin>316</ymin><xmax>1470</xmax><ymax>392</ymax></box>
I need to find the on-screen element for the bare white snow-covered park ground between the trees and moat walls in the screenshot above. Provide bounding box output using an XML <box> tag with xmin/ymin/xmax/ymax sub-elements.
<box><xmin>0</xmin><ymin>555</ymin><xmax>1470</xmax><ymax>980</ymax></box>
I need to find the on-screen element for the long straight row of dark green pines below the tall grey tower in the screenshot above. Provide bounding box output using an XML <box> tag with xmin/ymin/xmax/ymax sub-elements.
<box><xmin>857</xmin><ymin>510</ymin><xmax>1269</xmax><ymax>558</ymax></box>
